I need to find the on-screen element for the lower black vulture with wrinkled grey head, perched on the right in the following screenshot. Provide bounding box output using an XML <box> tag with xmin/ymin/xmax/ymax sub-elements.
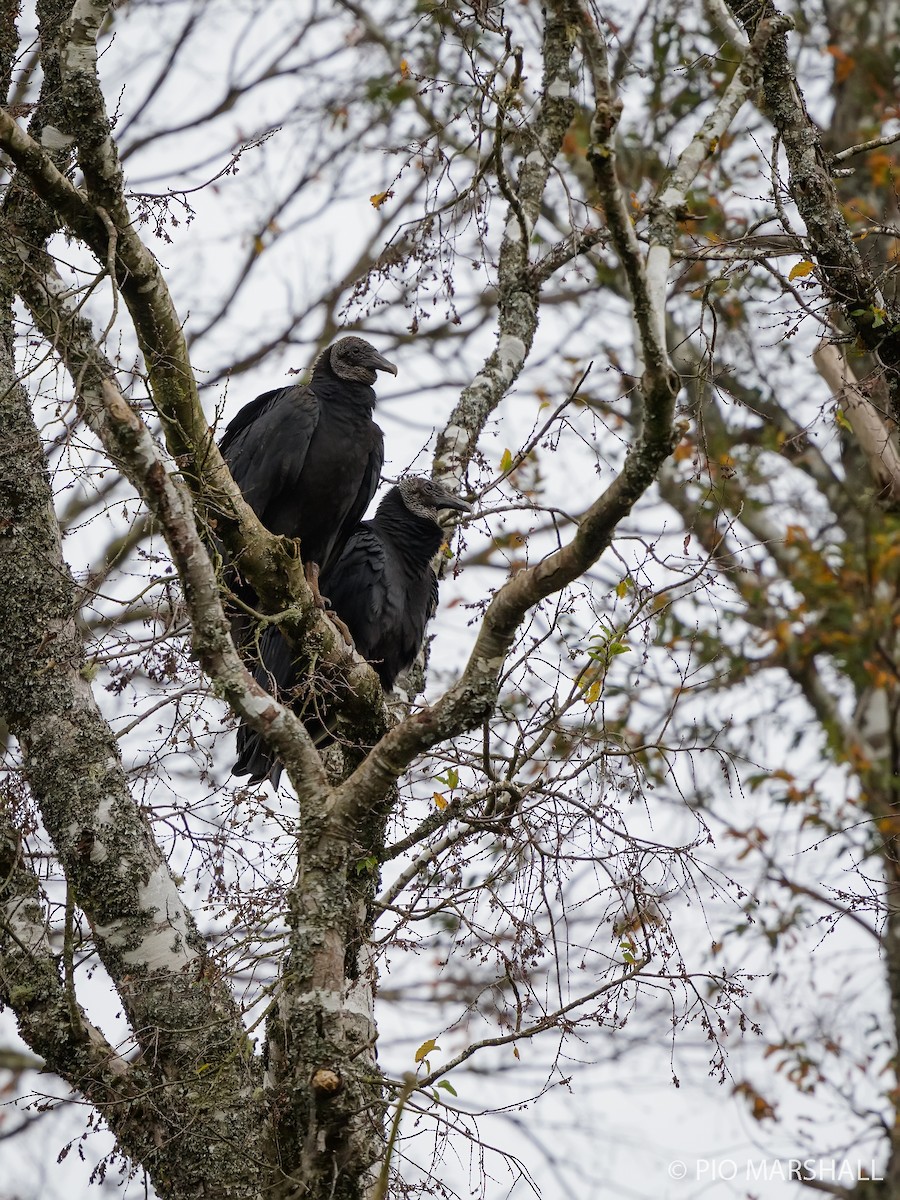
<box><xmin>232</xmin><ymin>475</ymin><xmax>469</xmax><ymax>787</ymax></box>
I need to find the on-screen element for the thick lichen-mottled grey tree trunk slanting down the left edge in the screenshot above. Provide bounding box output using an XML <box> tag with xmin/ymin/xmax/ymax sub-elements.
<box><xmin>0</xmin><ymin>248</ymin><xmax>265</xmax><ymax>1198</ymax></box>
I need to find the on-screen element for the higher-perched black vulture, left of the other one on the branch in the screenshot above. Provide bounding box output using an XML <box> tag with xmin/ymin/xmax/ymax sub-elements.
<box><xmin>218</xmin><ymin>337</ymin><xmax>397</xmax><ymax>604</ymax></box>
